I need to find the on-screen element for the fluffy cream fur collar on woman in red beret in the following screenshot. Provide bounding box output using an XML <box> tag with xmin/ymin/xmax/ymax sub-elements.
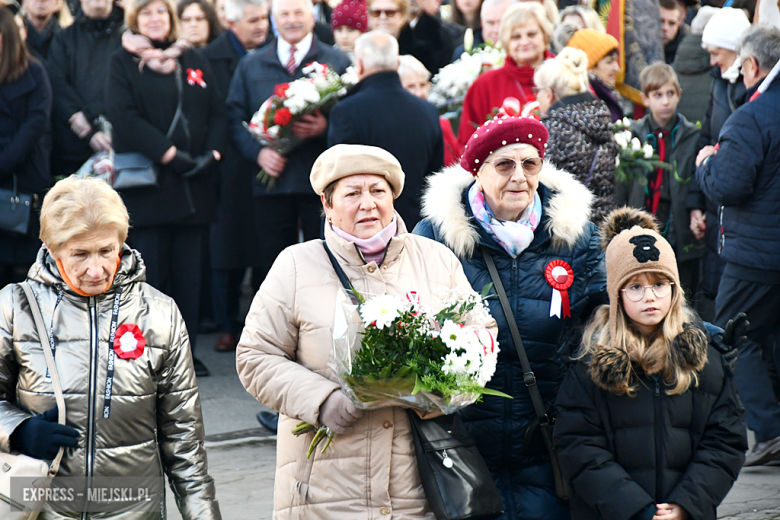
<box><xmin>421</xmin><ymin>161</ymin><xmax>594</xmax><ymax>258</ymax></box>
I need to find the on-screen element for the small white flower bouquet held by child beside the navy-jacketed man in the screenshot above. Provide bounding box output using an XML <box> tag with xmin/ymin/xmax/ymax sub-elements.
<box><xmin>612</xmin><ymin>117</ymin><xmax>672</xmax><ymax>185</ymax></box>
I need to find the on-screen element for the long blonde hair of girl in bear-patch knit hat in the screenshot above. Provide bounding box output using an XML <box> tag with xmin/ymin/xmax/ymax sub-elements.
<box><xmin>577</xmin><ymin>273</ymin><xmax>699</xmax><ymax>397</ymax></box>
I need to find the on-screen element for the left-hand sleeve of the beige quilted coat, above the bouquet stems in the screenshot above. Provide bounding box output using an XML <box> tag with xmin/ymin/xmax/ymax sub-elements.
<box><xmin>236</xmin><ymin>249</ymin><xmax>339</xmax><ymax>425</ymax></box>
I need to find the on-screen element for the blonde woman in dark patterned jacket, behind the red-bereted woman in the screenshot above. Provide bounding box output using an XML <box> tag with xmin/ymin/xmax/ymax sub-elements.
<box><xmin>534</xmin><ymin>47</ymin><xmax>618</xmax><ymax>225</ymax></box>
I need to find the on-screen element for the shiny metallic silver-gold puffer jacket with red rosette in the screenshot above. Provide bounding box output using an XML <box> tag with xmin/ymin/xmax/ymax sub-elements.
<box><xmin>0</xmin><ymin>246</ymin><xmax>221</xmax><ymax>520</ymax></box>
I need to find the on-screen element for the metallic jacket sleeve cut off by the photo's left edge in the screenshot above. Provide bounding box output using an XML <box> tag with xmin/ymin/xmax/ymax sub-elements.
<box><xmin>0</xmin><ymin>285</ymin><xmax>32</xmax><ymax>453</ymax></box>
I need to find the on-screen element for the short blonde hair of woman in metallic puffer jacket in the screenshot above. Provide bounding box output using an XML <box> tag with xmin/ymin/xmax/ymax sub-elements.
<box><xmin>40</xmin><ymin>175</ymin><xmax>130</xmax><ymax>253</ymax></box>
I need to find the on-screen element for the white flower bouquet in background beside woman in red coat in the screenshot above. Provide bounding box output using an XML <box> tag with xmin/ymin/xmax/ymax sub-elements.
<box><xmin>428</xmin><ymin>45</ymin><xmax>506</xmax><ymax>113</ymax></box>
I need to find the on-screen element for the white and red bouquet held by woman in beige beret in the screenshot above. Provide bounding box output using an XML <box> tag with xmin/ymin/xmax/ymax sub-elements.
<box><xmin>293</xmin><ymin>286</ymin><xmax>510</xmax><ymax>453</ymax></box>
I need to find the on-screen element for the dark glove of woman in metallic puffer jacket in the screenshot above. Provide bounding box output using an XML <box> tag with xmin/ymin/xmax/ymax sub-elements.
<box><xmin>10</xmin><ymin>406</ymin><xmax>81</xmax><ymax>460</ymax></box>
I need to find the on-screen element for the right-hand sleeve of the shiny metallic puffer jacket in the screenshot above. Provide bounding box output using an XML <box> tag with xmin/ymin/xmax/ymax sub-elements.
<box><xmin>157</xmin><ymin>301</ymin><xmax>222</xmax><ymax>520</ymax></box>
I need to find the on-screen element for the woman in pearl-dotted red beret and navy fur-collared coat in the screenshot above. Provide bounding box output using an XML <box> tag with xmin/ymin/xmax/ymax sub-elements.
<box><xmin>414</xmin><ymin>117</ymin><xmax>607</xmax><ymax>520</ymax></box>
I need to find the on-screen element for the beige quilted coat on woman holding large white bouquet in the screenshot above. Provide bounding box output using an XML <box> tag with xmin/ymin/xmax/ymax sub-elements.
<box><xmin>236</xmin><ymin>214</ymin><xmax>494</xmax><ymax>520</ymax></box>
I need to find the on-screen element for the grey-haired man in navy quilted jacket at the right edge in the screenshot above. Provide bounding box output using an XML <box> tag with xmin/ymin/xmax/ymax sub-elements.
<box><xmin>696</xmin><ymin>26</ymin><xmax>780</xmax><ymax>466</ymax></box>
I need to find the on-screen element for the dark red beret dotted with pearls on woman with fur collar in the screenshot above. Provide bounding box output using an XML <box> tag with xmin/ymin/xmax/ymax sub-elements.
<box><xmin>460</xmin><ymin>116</ymin><xmax>548</xmax><ymax>175</ymax></box>
